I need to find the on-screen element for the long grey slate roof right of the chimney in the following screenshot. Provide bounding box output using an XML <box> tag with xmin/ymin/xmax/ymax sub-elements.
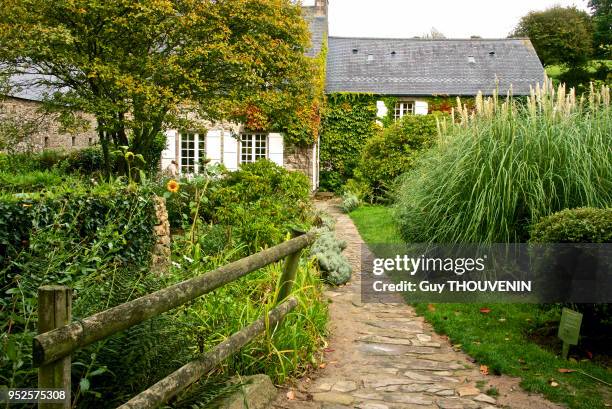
<box><xmin>327</xmin><ymin>37</ymin><xmax>544</xmax><ymax>96</ymax></box>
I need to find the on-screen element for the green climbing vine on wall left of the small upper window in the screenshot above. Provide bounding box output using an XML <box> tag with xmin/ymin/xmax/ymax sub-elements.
<box><xmin>320</xmin><ymin>93</ymin><xmax>380</xmax><ymax>191</ymax></box>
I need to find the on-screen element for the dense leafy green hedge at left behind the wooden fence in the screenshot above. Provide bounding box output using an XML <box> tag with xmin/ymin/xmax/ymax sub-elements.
<box><xmin>0</xmin><ymin>185</ymin><xmax>156</xmax><ymax>396</ymax></box>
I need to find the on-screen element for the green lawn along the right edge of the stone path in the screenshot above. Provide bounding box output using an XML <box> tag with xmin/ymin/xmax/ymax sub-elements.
<box><xmin>350</xmin><ymin>206</ymin><xmax>612</xmax><ymax>409</ymax></box>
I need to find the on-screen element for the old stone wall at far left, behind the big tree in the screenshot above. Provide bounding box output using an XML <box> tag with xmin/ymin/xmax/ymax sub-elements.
<box><xmin>0</xmin><ymin>98</ymin><xmax>98</xmax><ymax>152</ymax></box>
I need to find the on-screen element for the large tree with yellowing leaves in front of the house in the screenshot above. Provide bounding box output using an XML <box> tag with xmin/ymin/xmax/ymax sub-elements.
<box><xmin>0</xmin><ymin>0</ymin><xmax>316</xmax><ymax>174</ymax></box>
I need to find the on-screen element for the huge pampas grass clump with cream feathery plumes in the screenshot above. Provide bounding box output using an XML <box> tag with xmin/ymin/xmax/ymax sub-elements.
<box><xmin>395</xmin><ymin>81</ymin><xmax>612</xmax><ymax>243</ymax></box>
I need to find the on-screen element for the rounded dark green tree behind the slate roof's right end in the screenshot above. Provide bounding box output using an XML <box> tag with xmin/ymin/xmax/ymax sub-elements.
<box><xmin>511</xmin><ymin>6</ymin><xmax>593</xmax><ymax>67</ymax></box>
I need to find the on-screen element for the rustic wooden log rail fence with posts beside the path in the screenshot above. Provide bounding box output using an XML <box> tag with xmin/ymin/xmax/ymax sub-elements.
<box><xmin>32</xmin><ymin>232</ymin><xmax>315</xmax><ymax>409</ymax></box>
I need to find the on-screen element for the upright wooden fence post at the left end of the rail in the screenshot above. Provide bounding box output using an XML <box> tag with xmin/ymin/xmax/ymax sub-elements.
<box><xmin>38</xmin><ymin>285</ymin><xmax>72</xmax><ymax>409</ymax></box>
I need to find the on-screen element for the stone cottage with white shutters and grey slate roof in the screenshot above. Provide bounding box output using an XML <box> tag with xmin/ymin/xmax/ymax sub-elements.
<box><xmin>2</xmin><ymin>0</ymin><xmax>544</xmax><ymax>189</ymax></box>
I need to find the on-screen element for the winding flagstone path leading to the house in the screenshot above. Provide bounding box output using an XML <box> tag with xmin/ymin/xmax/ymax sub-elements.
<box><xmin>272</xmin><ymin>201</ymin><xmax>559</xmax><ymax>409</ymax></box>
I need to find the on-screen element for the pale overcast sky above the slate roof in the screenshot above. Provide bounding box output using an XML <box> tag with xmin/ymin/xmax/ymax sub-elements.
<box><xmin>303</xmin><ymin>0</ymin><xmax>588</xmax><ymax>38</ymax></box>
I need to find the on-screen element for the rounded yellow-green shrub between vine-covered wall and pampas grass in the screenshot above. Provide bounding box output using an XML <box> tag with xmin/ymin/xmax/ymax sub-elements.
<box><xmin>358</xmin><ymin>115</ymin><xmax>438</xmax><ymax>197</ymax></box>
